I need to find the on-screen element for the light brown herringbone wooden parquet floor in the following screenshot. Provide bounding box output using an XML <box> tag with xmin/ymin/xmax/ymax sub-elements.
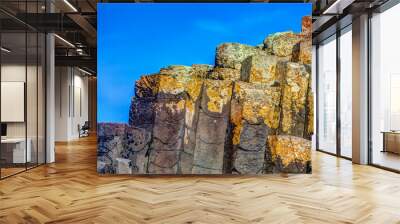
<box><xmin>0</xmin><ymin>137</ymin><xmax>400</xmax><ymax>224</ymax></box>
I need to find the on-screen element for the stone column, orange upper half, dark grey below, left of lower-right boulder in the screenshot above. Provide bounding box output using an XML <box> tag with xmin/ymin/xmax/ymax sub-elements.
<box><xmin>230</xmin><ymin>82</ymin><xmax>281</xmax><ymax>174</ymax></box>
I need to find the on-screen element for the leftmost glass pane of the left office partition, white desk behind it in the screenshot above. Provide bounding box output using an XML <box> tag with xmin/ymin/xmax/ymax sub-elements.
<box><xmin>1</xmin><ymin>32</ymin><xmax>27</xmax><ymax>178</ymax></box>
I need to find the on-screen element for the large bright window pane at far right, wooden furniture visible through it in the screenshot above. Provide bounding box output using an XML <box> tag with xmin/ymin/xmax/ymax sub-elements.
<box><xmin>371</xmin><ymin>5</ymin><xmax>400</xmax><ymax>170</ymax></box>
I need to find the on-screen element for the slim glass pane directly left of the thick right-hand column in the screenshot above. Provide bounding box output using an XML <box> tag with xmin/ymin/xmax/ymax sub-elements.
<box><xmin>340</xmin><ymin>27</ymin><xmax>353</xmax><ymax>158</ymax></box>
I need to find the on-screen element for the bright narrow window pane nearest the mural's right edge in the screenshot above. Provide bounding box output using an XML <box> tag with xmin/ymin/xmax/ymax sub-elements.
<box><xmin>318</xmin><ymin>36</ymin><xmax>336</xmax><ymax>153</ymax></box>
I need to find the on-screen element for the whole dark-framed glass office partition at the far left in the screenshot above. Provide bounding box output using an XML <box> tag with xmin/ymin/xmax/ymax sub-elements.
<box><xmin>0</xmin><ymin>1</ymin><xmax>46</xmax><ymax>178</ymax></box>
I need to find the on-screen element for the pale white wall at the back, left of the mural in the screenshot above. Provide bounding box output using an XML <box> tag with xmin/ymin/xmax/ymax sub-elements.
<box><xmin>55</xmin><ymin>67</ymin><xmax>88</xmax><ymax>141</ymax></box>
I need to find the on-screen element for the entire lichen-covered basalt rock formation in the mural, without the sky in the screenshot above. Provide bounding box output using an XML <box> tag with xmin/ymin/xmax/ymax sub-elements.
<box><xmin>97</xmin><ymin>3</ymin><xmax>313</xmax><ymax>174</ymax></box>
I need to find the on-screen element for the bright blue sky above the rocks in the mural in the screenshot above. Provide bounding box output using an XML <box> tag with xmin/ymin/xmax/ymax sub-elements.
<box><xmin>97</xmin><ymin>3</ymin><xmax>311</xmax><ymax>122</ymax></box>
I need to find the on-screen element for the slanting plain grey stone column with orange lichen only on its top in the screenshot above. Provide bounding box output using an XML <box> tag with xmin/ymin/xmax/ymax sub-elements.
<box><xmin>192</xmin><ymin>80</ymin><xmax>232</xmax><ymax>174</ymax></box>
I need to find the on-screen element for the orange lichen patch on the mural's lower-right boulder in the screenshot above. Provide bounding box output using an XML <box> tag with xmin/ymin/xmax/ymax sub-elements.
<box><xmin>268</xmin><ymin>135</ymin><xmax>311</xmax><ymax>166</ymax></box>
